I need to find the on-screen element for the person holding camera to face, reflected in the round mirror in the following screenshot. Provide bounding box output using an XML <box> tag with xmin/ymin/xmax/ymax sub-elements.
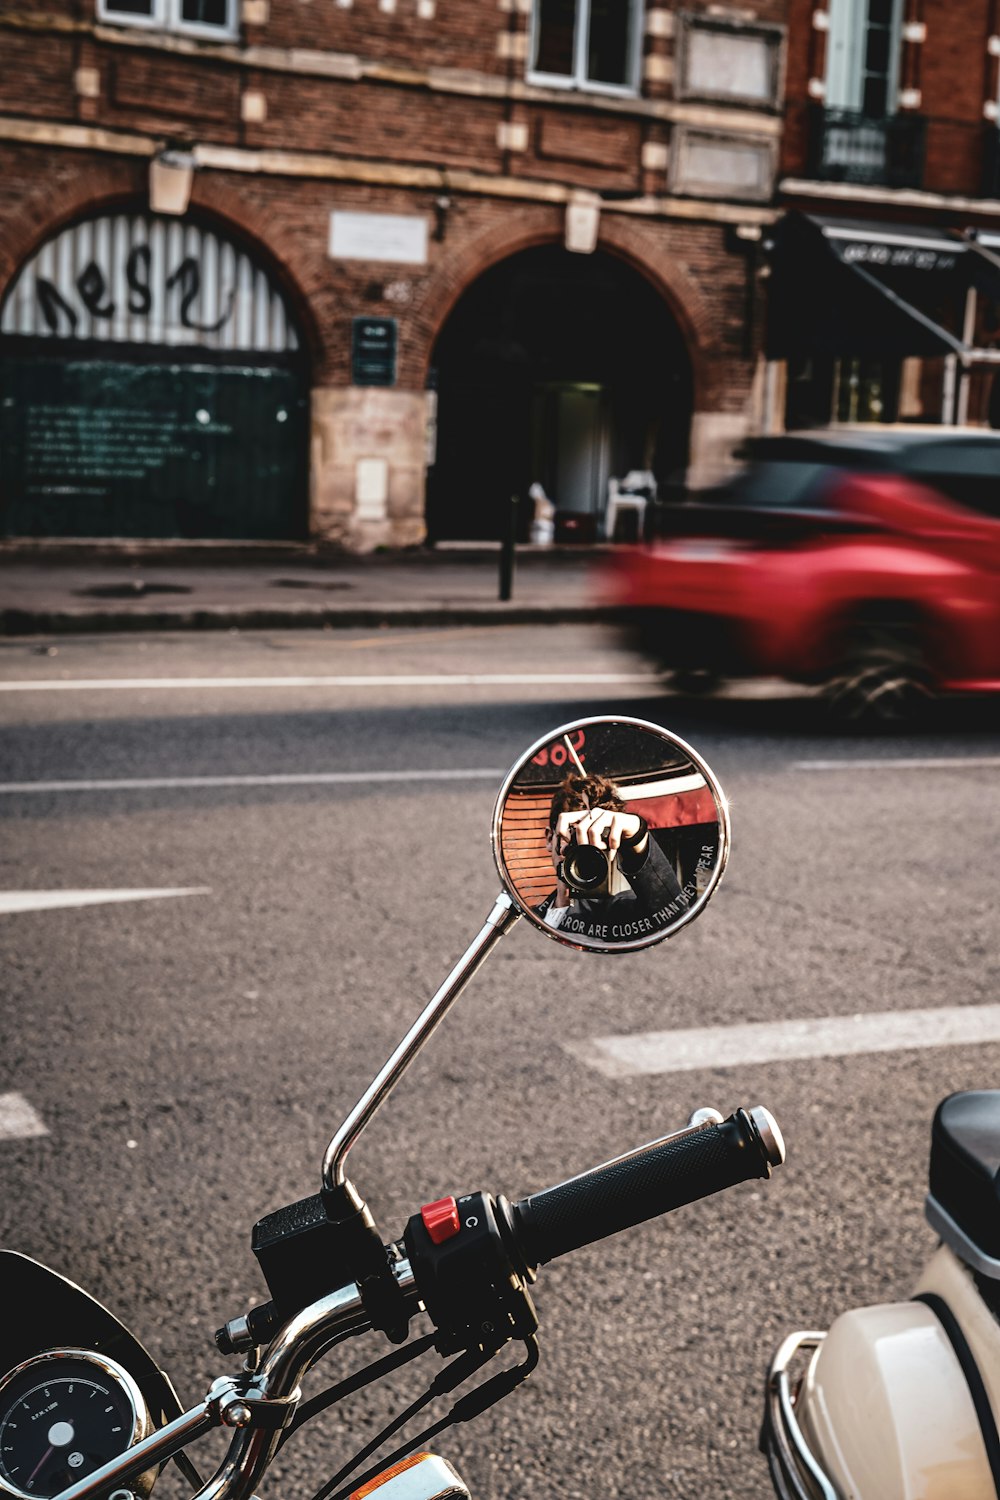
<box><xmin>534</xmin><ymin>776</ymin><xmax>688</xmax><ymax>942</ymax></box>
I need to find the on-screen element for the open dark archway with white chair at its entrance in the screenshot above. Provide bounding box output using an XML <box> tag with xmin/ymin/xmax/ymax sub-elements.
<box><xmin>427</xmin><ymin>246</ymin><xmax>691</xmax><ymax>542</ymax></box>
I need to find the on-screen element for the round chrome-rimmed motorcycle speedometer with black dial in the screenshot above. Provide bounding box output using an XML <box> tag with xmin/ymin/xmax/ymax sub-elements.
<box><xmin>0</xmin><ymin>1349</ymin><xmax>151</xmax><ymax>1500</ymax></box>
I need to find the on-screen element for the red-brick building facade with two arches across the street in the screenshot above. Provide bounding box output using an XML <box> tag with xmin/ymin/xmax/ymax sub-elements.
<box><xmin>0</xmin><ymin>0</ymin><xmax>1000</xmax><ymax>548</ymax></box>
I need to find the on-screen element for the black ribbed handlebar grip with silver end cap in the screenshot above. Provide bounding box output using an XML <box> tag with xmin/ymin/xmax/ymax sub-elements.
<box><xmin>513</xmin><ymin>1109</ymin><xmax>784</xmax><ymax>1268</ymax></box>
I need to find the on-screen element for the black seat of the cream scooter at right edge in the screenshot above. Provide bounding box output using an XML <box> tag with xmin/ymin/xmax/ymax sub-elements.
<box><xmin>930</xmin><ymin>1089</ymin><xmax>1000</xmax><ymax>1262</ymax></box>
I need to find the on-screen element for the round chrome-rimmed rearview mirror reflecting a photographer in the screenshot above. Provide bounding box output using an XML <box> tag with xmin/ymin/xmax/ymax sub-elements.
<box><xmin>493</xmin><ymin>717</ymin><xmax>729</xmax><ymax>953</ymax></box>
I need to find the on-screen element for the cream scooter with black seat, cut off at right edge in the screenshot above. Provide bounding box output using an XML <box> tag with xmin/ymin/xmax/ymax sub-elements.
<box><xmin>762</xmin><ymin>1089</ymin><xmax>1000</xmax><ymax>1500</ymax></box>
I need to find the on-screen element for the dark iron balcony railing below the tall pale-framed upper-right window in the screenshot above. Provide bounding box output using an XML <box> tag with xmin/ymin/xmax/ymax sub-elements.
<box><xmin>810</xmin><ymin>110</ymin><xmax>927</xmax><ymax>188</ymax></box>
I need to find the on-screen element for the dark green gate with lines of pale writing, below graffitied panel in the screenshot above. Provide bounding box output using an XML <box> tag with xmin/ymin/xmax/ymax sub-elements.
<box><xmin>0</xmin><ymin>357</ymin><xmax>309</xmax><ymax>540</ymax></box>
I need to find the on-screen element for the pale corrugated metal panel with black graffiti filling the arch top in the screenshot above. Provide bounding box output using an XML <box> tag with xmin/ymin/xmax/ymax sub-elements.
<box><xmin>0</xmin><ymin>215</ymin><xmax>298</xmax><ymax>354</ymax></box>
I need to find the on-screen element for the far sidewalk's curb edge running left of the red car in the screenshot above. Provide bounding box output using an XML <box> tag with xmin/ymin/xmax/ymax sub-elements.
<box><xmin>0</xmin><ymin>603</ymin><xmax>618</xmax><ymax>636</ymax></box>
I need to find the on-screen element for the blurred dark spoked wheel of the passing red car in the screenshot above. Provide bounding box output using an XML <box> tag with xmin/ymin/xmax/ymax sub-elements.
<box><xmin>823</xmin><ymin>623</ymin><xmax>934</xmax><ymax>729</ymax></box>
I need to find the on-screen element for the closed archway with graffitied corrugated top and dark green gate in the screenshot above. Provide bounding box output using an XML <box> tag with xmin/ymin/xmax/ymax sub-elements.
<box><xmin>0</xmin><ymin>213</ymin><xmax>309</xmax><ymax>540</ymax></box>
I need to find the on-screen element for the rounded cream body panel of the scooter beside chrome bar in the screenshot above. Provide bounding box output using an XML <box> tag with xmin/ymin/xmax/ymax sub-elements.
<box><xmin>796</xmin><ymin>1302</ymin><xmax>996</xmax><ymax>1500</ymax></box>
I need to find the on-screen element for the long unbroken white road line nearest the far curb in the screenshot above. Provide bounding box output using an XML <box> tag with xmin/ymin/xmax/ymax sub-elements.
<box><xmin>0</xmin><ymin>672</ymin><xmax>661</xmax><ymax>693</ymax></box>
